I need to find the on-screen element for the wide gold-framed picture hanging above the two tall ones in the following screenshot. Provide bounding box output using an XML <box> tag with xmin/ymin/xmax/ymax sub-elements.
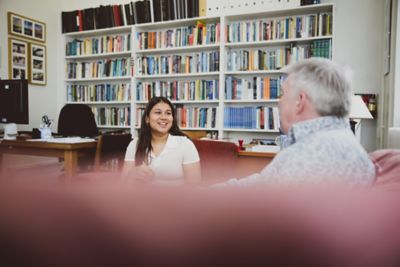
<box><xmin>7</xmin><ymin>12</ymin><xmax>46</xmax><ymax>43</ymax></box>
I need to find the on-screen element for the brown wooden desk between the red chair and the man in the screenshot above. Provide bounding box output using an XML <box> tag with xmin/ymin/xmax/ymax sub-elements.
<box><xmin>237</xmin><ymin>151</ymin><xmax>276</xmax><ymax>177</ymax></box>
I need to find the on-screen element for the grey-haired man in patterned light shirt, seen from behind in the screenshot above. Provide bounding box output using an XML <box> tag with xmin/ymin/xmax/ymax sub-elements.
<box><xmin>217</xmin><ymin>58</ymin><xmax>375</xmax><ymax>186</ymax></box>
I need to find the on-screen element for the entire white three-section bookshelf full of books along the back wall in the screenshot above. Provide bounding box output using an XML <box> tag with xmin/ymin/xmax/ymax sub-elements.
<box><xmin>64</xmin><ymin>4</ymin><xmax>334</xmax><ymax>143</ymax></box>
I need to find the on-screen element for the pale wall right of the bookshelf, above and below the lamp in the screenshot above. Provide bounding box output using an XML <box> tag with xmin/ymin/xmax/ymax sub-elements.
<box><xmin>321</xmin><ymin>0</ymin><xmax>383</xmax><ymax>151</ymax></box>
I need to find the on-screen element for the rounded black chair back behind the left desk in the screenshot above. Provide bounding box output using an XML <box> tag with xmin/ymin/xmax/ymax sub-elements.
<box><xmin>58</xmin><ymin>104</ymin><xmax>99</xmax><ymax>137</ymax></box>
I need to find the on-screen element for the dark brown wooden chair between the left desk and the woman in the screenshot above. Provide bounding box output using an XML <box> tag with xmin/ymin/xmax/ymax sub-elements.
<box><xmin>95</xmin><ymin>132</ymin><xmax>132</xmax><ymax>171</ymax></box>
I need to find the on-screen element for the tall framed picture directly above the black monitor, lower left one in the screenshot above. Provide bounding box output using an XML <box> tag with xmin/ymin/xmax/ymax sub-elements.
<box><xmin>8</xmin><ymin>38</ymin><xmax>28</xmax><ymax>79</ymax></box>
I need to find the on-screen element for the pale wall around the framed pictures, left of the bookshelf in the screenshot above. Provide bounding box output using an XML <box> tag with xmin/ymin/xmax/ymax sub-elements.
<box><xmin>0</xmin><ymin>0</ymin><xmax>60</xmax><ymax>133</ymax></box>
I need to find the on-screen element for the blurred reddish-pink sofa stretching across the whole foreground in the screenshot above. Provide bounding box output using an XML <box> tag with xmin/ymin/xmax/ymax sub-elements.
<box><xmin>0</xmin><ymin>150</ymin><xmax>400</xmax><ymax>267</ymax></box>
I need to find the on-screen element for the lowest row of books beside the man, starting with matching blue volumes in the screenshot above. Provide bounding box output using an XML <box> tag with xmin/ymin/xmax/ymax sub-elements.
<box><xmin>224</xmin><ymin>106</ymin><xmax>280</xmax><ymax>131</ymax></box>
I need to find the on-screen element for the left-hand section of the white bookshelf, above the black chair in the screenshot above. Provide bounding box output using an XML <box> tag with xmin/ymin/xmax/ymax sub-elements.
<box><xmin>64</xmin><ymin>26</ymin><xmax>132</xmax><ymax>130</ymax></box>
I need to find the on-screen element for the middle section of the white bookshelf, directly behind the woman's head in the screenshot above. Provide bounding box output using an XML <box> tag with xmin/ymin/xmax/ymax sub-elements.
<box><xmin>133</xmin><ymin>17</ymin><xmax>221</xmax><ymax>134</ymax></box>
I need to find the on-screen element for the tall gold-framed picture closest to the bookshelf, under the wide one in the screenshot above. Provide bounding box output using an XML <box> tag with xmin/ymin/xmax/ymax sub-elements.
<box><xmin>29</xmin><ymin>43</ymin><xmax>47</xmax><ymax>85</ymax></box>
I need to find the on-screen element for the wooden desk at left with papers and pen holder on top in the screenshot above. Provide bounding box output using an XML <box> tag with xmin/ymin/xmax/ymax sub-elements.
<box><xmin>0</xmin><ymin>140</ymin><xmax>97</xmax><ymax>183</ymax></box>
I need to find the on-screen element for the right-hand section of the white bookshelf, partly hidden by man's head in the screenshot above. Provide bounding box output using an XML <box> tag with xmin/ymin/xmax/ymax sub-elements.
<box><xmin>220</xmin><ymin>4</ymin><xmax>334</xmax><ymax>143</ymax></box>
